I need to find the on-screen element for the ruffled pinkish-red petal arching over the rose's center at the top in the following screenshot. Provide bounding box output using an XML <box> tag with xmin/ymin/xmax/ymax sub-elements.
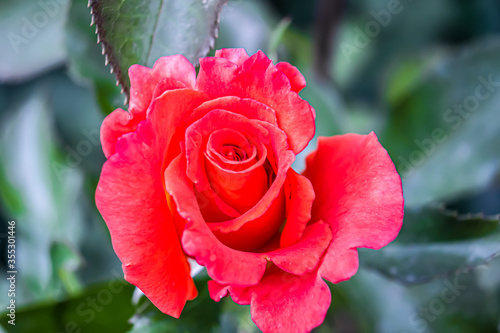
<box><xmin>197</xmin><ymin>51</ymin><xmax>315</xmax><ymax>154</ymax></box>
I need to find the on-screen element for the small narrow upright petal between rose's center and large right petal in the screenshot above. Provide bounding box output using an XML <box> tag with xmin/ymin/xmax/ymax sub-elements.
<box><xmin>280</xmin><ymin>169</ymin><xmax>315</xmax><ymax>247</ymax></box>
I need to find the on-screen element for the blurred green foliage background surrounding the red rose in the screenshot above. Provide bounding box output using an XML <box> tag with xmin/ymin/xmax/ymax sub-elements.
<box><xmin>0</xmin><ymin>0</ymin><xmax>500</xmax><ymax>333</ymax></box>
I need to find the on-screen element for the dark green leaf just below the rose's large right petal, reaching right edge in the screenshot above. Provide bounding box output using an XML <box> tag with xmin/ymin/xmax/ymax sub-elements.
<box><xmin>360</xmin><ymin>209</ymin><xmax>500</xmax><ymax>284</ymax></box>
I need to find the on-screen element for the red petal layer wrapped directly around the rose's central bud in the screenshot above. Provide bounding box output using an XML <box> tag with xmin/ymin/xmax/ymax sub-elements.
<box><xmin>185</xmin><ymin>110</ymin><xmax>295</xmax><ymax>251</ymax></box>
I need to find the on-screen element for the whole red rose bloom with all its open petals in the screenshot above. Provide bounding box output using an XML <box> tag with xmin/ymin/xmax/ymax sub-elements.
<box><xmin>96</xmin><ymin>49</ymin><xmax>403</xmax><ymax>332</ymax></box>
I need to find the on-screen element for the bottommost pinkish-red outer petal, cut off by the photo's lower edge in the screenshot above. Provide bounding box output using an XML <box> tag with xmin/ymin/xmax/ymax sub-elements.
<box><xmin>208</xmin><ymin>267</ymin><xmax>331</xmax><ymax>333</ymax></box>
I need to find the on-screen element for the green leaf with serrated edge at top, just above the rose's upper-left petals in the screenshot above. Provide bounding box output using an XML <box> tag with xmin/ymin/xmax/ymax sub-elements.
<box><xmin>89</xmin><ymin>0</ymin><xmax>227</xmax><ymax>95</ymax></box>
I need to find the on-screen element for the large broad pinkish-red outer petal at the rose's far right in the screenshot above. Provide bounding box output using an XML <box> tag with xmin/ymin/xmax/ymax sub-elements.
<box><xmin>304</xmin><ymin>132</ymin><xmax>404</xmax><ymax>283</ymax></box>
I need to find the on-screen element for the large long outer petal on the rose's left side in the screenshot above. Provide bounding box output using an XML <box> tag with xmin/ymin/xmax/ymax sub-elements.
<box><xmin>96</xmin><ymin>122</ymin><xmax>197</xmax><ymax>318</ymax></box>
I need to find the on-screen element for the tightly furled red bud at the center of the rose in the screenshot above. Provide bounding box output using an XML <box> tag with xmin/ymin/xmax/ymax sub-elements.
<box><xmin>205</xmin><ymin>129</ymin><xmax>269</xmax><ymax>214</ymax></box>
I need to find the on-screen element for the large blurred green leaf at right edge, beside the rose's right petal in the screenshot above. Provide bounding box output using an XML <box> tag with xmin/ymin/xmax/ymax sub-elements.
<box><xmin>381</xmin><ymin>38</ymin><xmax>500</xmax><ymax>207</ymax></box>
